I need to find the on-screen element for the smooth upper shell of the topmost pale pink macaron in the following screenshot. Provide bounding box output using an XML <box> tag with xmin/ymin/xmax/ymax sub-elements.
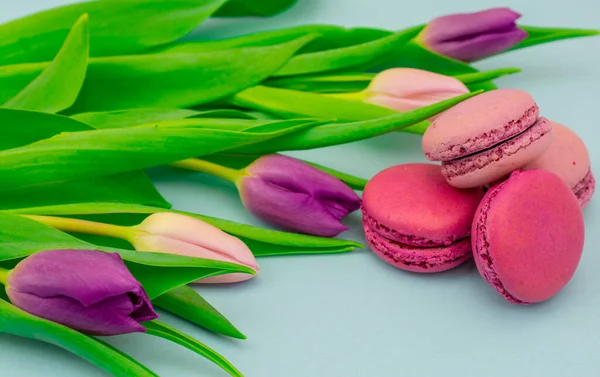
<box><xmin>422</xmin><ymin>89</ymin><xmax>539</xmax><ymax>161</ymax></box>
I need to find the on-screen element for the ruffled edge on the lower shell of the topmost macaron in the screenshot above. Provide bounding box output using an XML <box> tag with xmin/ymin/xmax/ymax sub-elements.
<box><xmin>442</xmin><ymin>117</ymin><xmax>552</xmax><ymax>178</ymax></box>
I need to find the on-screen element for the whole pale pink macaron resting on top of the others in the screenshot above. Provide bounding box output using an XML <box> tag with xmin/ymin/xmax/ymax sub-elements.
<box><xmin>422</xmin><ymin>89</ymin><xmax>552</xmax><ymax>188</ymax></box>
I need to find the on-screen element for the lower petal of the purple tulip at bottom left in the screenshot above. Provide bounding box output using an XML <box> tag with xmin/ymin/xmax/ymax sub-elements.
<box><xmin>7</xmin><ymin>287</ymin><xmax>158</xmax><ymax>336</ymax></box>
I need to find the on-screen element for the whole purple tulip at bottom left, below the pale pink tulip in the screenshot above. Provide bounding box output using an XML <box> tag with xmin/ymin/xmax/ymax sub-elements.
<box><xmin>6</xmin><ymin>250</ymin><xmax>158</xmax><ymax>335</ymax></box>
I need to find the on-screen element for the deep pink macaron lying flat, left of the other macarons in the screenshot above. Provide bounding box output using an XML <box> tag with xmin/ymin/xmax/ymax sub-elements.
<box><xmin>361</xmin><ymin>163</ymin><xmax>483</xmax><ymax>273</ymax></box>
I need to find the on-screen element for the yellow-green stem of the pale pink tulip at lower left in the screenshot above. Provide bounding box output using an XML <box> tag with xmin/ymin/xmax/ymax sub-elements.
<box><xmin>21</xmin><ymin>215</ymin><xmax>131</xmax><ymax>240</ymax></box>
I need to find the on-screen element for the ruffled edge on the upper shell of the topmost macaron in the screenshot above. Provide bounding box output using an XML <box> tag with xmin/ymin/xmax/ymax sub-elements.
<box><xmin>425</xmin><ymin>105</ymin><xmax>539</xmax><ymax>161</ymax></box>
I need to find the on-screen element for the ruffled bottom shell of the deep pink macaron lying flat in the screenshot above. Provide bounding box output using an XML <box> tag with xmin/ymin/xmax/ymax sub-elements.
<box><xmin>365</xmin><ymin>220</ymin><xmax>472</xmax><ymax>273</ymax></box>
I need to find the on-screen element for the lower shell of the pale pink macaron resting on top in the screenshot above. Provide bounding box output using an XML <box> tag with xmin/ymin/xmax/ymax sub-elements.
<box><xmin>442</xmin><ymin>118</ymin><xmax>553</xmax><ymax>188</ymax></box>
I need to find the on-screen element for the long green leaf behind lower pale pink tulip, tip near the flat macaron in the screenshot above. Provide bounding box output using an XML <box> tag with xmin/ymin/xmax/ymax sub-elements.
<box><xmin>5</xmin><ymin>203</ymin><xmax>363</xmax><ymax>255</ymax></box>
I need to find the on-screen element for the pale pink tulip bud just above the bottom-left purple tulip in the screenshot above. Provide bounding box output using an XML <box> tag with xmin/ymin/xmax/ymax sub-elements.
<box><xmin>128</xmin><ymin>212</ymin><xmax>259</xmax><ymax>283</ymax></box>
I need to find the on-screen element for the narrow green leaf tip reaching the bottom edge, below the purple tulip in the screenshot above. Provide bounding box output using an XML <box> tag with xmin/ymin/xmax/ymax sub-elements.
<box><xmin>144</xmin><ymin>321</ymin><xmax>243</xmax><ymax>377</ymax></box>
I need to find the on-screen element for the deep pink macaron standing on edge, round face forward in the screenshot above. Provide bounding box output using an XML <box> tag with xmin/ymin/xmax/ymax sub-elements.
<box><xmin>471</xmin><ymin>169</ymin><xmax>584</xmax><ymax>304</ymax></box>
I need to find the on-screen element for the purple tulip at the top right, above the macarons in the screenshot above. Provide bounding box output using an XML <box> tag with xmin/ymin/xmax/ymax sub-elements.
<box><xmin>419</xmin><ymin>8</ymin><xmax>527</xmax><ymax>62</ymax></box>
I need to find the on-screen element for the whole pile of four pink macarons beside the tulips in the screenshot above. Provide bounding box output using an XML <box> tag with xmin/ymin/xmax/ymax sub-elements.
<box><xmin>362</xmin><ymin>89</ymin><xmax>595</xmax><ymax>304</ymax></box>
